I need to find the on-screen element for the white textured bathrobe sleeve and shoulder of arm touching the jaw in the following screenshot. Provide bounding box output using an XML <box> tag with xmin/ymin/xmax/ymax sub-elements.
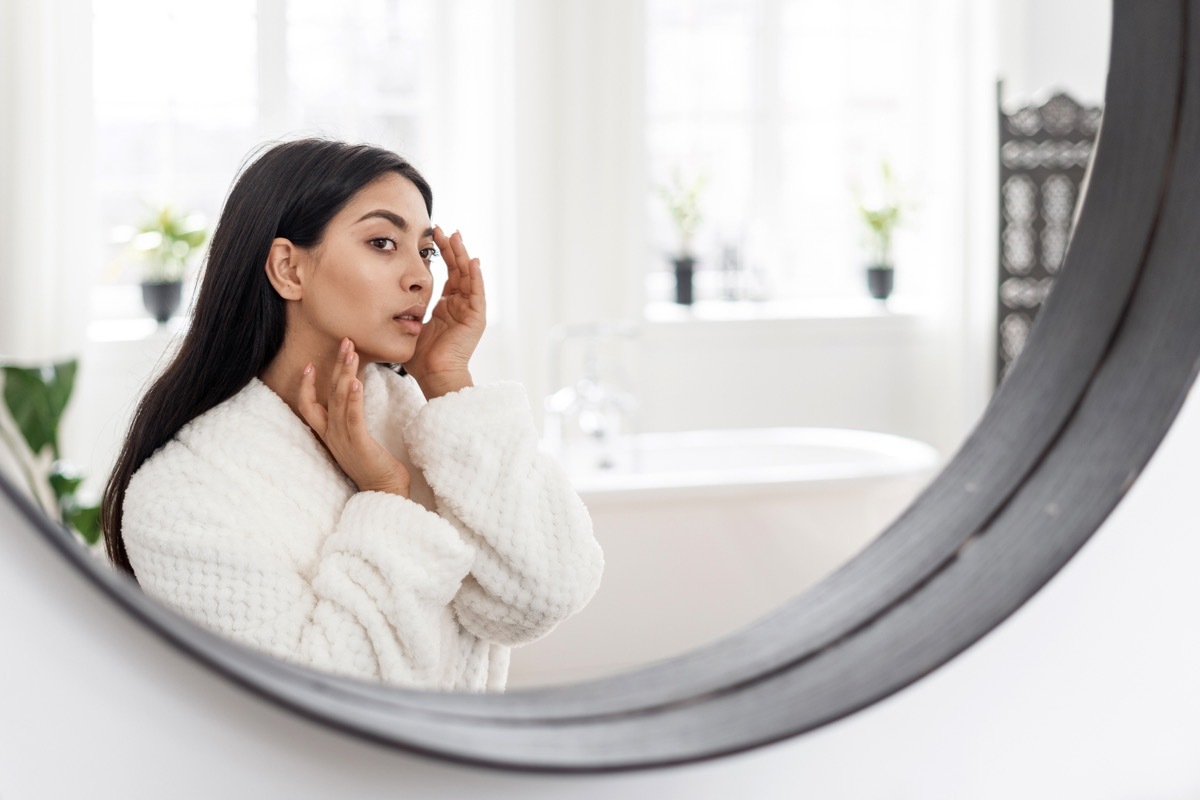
<box><xmin>124</xmin><ymin>453</ymin><xmax>477</xmax><ymax>688</ymax></box>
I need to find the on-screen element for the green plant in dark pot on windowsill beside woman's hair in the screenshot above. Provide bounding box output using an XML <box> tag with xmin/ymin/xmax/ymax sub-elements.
<box><xmin>132</xmin><ymin>205</ymin><xmax>208</xmax><ymax>324</ymax></box>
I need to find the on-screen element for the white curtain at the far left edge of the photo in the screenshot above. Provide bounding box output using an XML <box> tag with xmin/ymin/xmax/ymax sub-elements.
<box><xmin>0</xmin><ymin>0</ymin><xmax>93</xmax><ymax>361</ymax></box>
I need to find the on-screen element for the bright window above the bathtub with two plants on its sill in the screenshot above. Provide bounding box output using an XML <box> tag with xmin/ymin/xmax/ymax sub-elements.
<box><xmin>646</xmin><ymin>0</ymin><xmax>936</xmax><ymax>302</ymax></box>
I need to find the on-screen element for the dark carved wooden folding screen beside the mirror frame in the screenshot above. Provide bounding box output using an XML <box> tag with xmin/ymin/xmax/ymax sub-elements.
<box><xmin>996</xmin><ymin>92</ymin><xmax>1102</xmax><ymax>384</ymax></box>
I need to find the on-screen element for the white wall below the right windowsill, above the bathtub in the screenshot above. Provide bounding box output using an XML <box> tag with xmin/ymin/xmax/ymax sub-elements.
<box><xmin>638</xmin><ymin>303</ymin><xmax>926</xmax><ymax>444</ymax></box>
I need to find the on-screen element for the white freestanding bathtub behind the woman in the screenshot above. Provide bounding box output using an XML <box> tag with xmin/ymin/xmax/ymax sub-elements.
<box><xmin>509</xmin><ymin>428</ymin><xmax>938</xmax><ymax>688</ymax></box>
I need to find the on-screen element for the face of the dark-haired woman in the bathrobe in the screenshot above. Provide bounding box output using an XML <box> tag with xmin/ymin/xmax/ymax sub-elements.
<box><xmin>295</xmin><ymin>173</ymin><xmax>437</xmax><ymax>363</ymax></box>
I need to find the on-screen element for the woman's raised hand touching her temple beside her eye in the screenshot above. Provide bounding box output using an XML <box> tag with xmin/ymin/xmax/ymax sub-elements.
<box><xmin>404</xmin><ymin>228</ymin><xmax>487</xmax><ymax>399</ymax></box>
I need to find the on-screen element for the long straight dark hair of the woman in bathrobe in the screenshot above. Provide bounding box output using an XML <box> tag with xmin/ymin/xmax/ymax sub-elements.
<box><xmin>101</xmin><ymin>139</ymin><xmax>433</xmax><ymax>577</ymax></box>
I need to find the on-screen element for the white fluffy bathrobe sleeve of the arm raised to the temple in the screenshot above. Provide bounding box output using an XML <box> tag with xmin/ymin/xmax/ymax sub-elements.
<box><xmin>406</xmin><ymin>383</ymin><xmax>604</xmax><ymax>646</ymax></box>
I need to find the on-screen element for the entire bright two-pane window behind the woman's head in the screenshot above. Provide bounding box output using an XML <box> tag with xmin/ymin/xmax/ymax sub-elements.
<box><xmin>92</xmin><ymin>0</ymin><xmax>437</xmax><ymax>317</ymax></box>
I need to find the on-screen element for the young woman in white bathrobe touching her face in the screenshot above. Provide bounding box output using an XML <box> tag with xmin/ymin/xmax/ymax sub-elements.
<box><xmin>103</xmin><ymin>139</ymin><xmax>602</xmax><ymax>691</ymax></box>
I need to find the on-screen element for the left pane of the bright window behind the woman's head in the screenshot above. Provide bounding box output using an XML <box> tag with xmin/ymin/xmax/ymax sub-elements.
<box><xmin>92</xmin><ymin>0</ymin><xmax>259</xmax><ymax>288</ymax></box>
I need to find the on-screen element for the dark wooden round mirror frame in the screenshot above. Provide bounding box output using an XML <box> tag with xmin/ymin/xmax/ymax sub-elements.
<box><xmin>0</xmin><ymin>0</ymin><xmax>1200</xmax><ymax>772</ymax></box>
